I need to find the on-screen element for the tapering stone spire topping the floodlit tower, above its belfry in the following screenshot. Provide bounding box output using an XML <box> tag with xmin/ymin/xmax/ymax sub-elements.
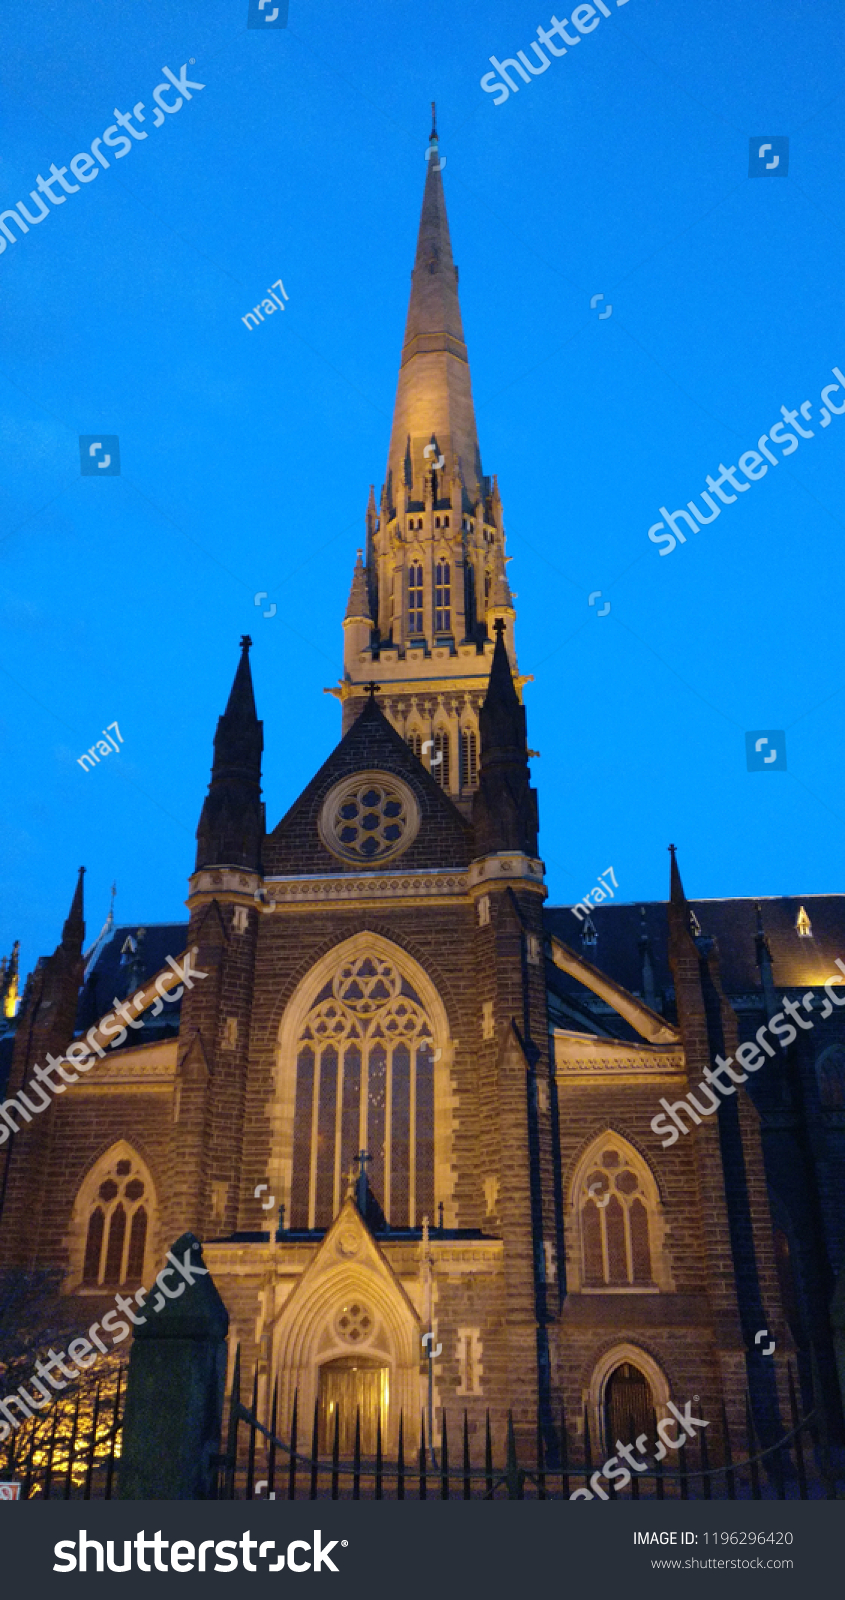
<box><xmin>386</xmin><ymin>104</ymin><xmax>483</xmax><ymax>515</ymax></box>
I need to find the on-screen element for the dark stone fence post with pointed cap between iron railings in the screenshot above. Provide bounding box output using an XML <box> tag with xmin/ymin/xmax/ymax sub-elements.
<box><xmin>120</xmin><ymin>1234</ymin><xmax>229</xmax><ymax>1501</ymax></box>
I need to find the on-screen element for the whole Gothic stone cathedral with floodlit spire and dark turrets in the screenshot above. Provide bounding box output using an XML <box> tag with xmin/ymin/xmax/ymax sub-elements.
<box><xmin>0</xmin><ymin>116</ymin><xmax>845</xmax><ymax>1451</ymax></box>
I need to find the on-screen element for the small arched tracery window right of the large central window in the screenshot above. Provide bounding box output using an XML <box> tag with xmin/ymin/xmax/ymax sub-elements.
<box><xmin>575</xmin><ymin>1134</ymin><xmax>658</xmax><ymax>1290</ymax></box>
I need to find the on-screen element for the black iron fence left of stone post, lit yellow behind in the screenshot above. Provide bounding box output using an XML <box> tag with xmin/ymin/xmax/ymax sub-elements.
<box><xmin>0</xmin><ymin>1366</ymin><xmax>126</xmax><ymax>1499</ymax></box>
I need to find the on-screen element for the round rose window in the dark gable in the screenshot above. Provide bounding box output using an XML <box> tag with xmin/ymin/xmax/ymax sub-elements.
<box><xmin>318</xmin><ymin>773</ymin><xmax>419</xmax><ymax>862</ymax></box>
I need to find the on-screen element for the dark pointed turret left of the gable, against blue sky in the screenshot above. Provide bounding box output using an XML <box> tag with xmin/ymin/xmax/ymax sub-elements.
<box><xmin>197</xmin><ymin>634</ymin><xmax>264</xmax><ymax>872</ymax></box>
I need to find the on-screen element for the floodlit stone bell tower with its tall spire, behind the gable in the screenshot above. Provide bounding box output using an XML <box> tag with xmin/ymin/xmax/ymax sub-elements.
<box><xmin>326</xmin><ymin>106</ymin><xmax>530</xmax><ymax>816</ymax></box>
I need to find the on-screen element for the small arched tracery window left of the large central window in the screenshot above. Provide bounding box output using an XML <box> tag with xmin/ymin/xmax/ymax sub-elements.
<box><xmin>82</xmin><ymin>1154</ymin><xmax>152</xmax><ymax>1288</ymax></box>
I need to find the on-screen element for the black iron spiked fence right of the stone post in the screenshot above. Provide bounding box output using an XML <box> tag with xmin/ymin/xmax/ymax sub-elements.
<box><xmin>218</xmin><ymin>1350</ymin><xmax>845</xmax><ymax>1501</ymax></box>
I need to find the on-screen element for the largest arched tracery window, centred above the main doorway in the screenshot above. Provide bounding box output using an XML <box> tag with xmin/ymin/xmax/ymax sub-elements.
<box><xmin>291</xmin><ymin>955</ymin><xmax>434</xmax><ymax>1229</ymax></box>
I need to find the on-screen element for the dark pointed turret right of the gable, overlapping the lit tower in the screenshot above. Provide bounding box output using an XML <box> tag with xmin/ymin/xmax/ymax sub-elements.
<box><xmin>472</xmin><ymin>618</ymin><xmax>539</xmax><ymax>856</ymax></box>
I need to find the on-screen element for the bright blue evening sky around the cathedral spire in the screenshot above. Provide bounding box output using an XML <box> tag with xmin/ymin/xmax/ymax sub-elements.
<box><xmin>0</xmin><ymin>0</ymin><xmax>845</xmax><ymax>968</ymax></box>
